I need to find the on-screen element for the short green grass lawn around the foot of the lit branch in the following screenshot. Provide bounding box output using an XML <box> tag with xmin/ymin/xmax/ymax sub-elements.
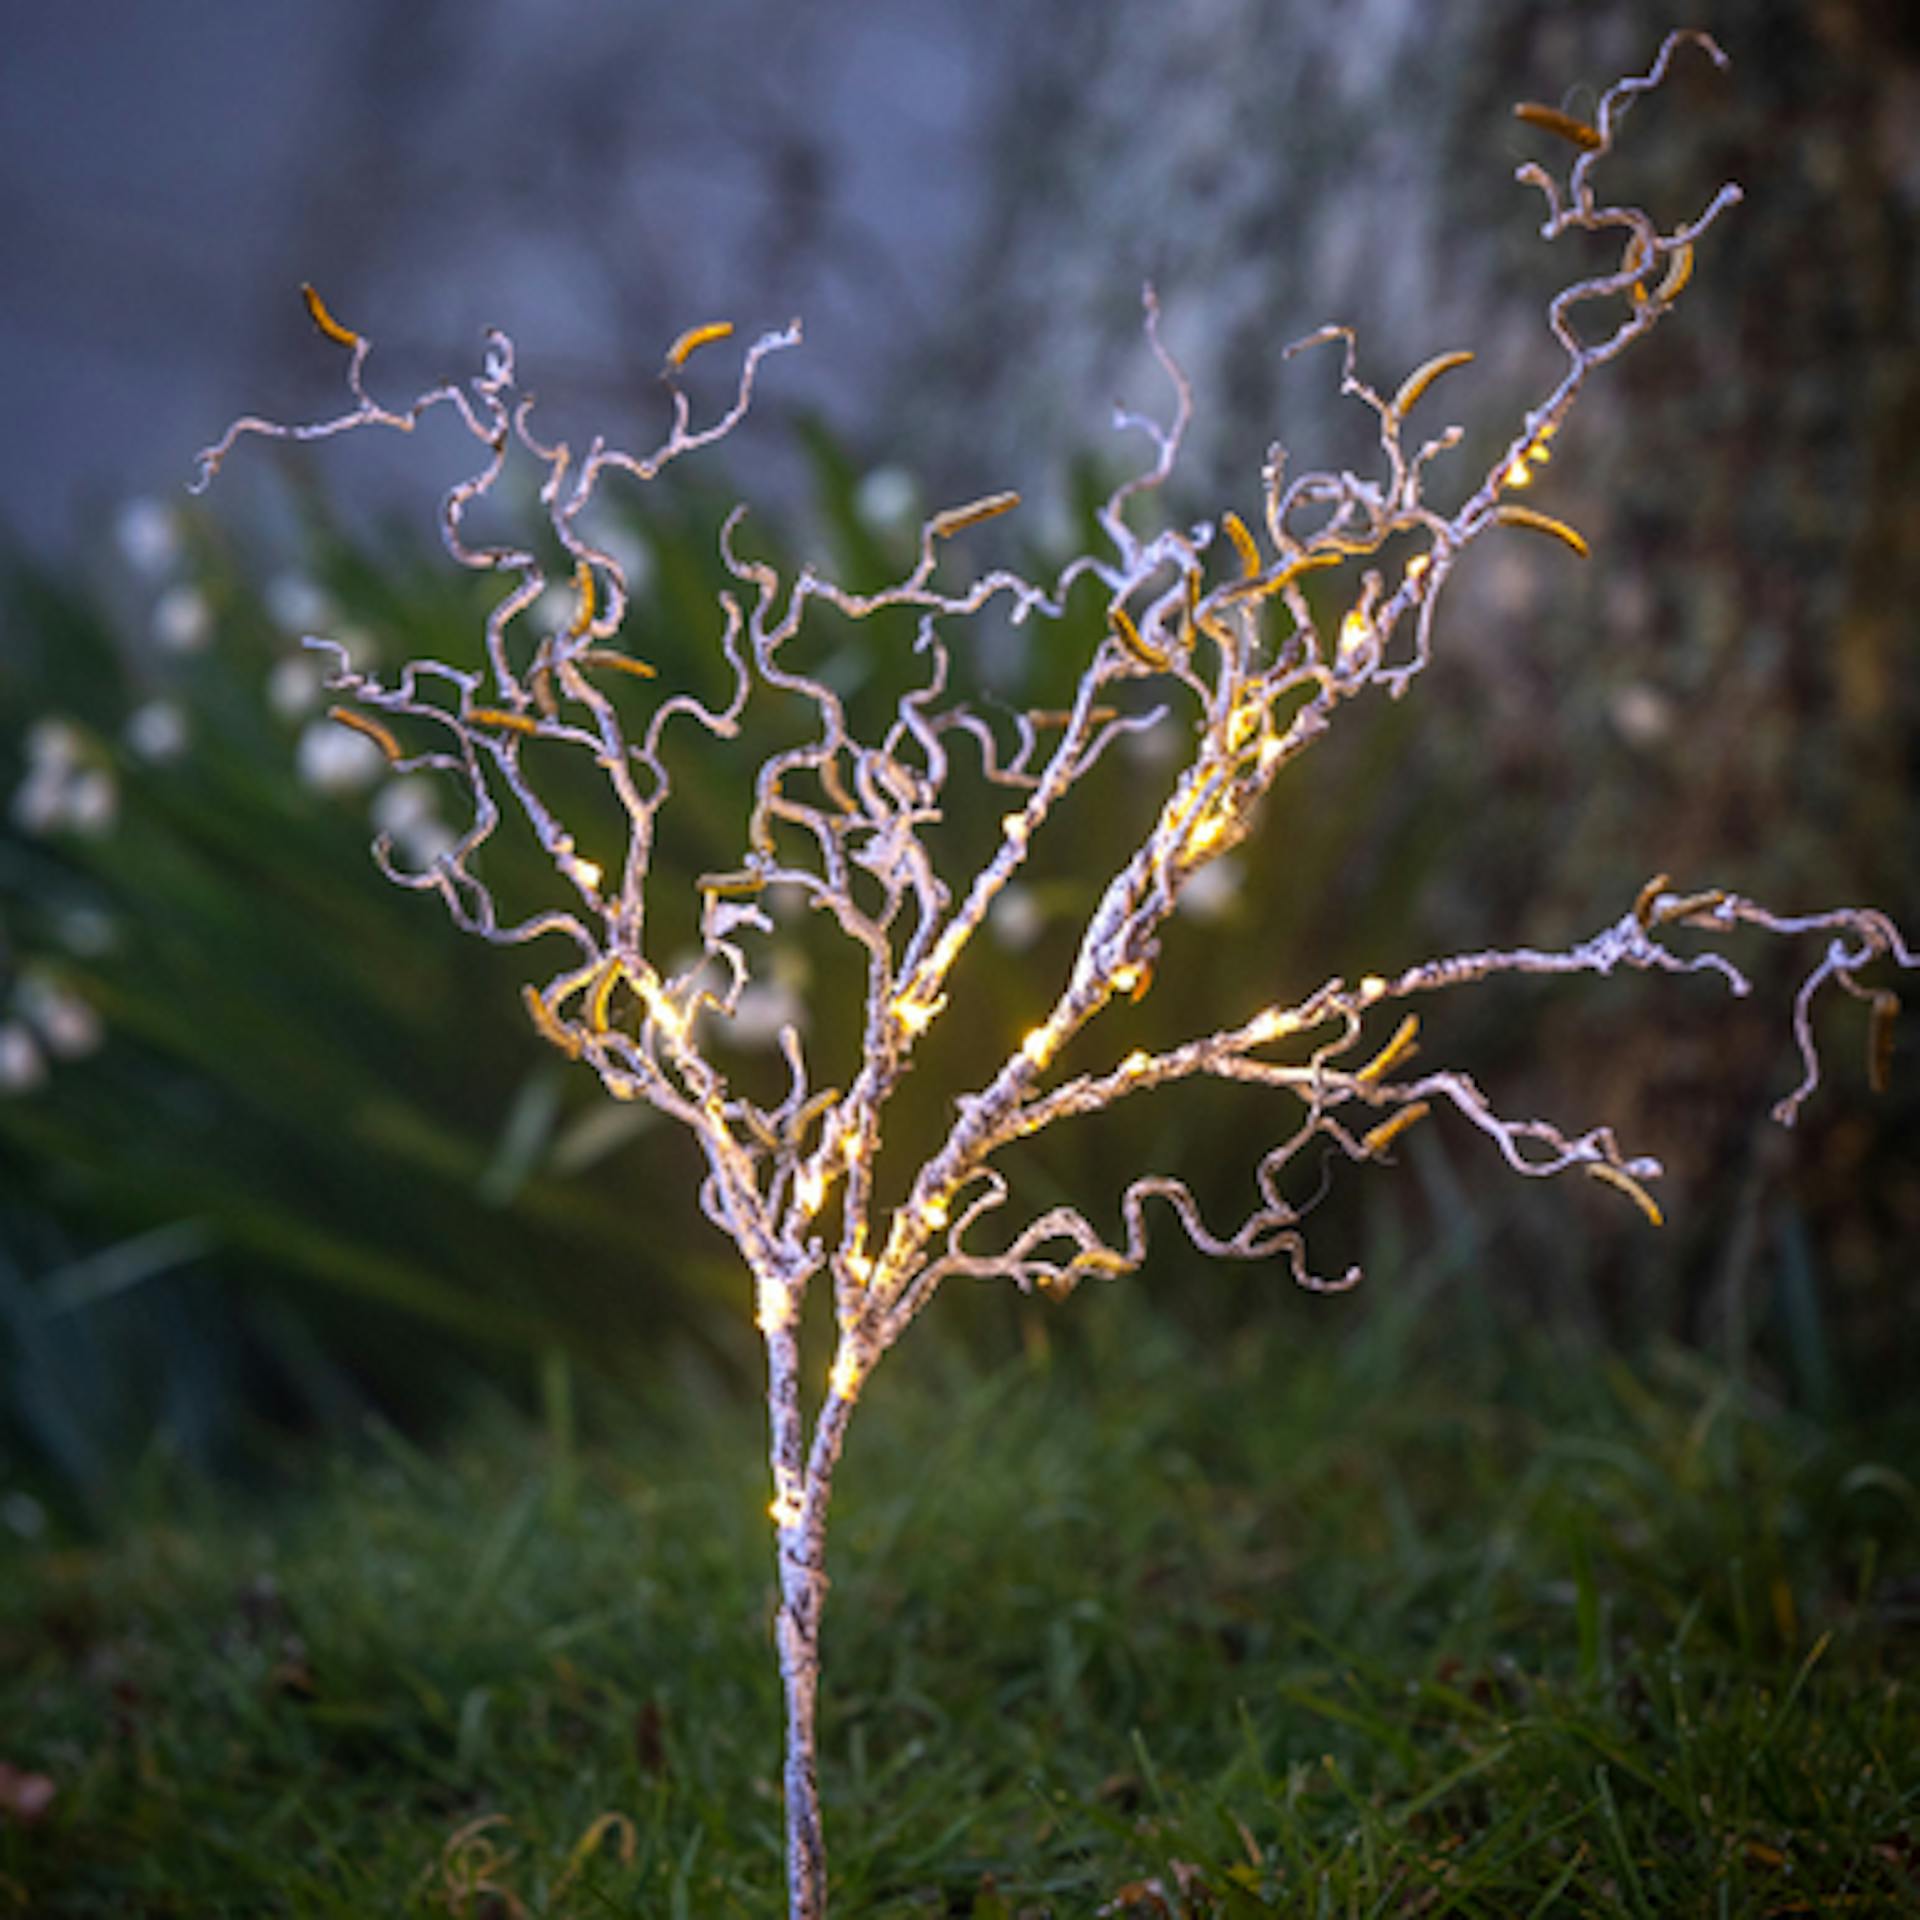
<box><xmin>0</xmin><ymin>1288</ymin><xmax>1920</xmax><ymax>1920</ymax></box>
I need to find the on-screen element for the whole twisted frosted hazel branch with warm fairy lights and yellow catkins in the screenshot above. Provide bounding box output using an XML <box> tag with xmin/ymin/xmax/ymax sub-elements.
<box><xmin>198</xmin><ymin>33</ymin><xmax>1916</xmax><ymax>1920</ymax></box>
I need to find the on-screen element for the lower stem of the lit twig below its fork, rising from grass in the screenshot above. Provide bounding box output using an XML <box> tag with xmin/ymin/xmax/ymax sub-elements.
<box><xmin>766</xmin><ymin>1315</ymin><xmax>852</xmax><ymax>1920</ymax></box>
